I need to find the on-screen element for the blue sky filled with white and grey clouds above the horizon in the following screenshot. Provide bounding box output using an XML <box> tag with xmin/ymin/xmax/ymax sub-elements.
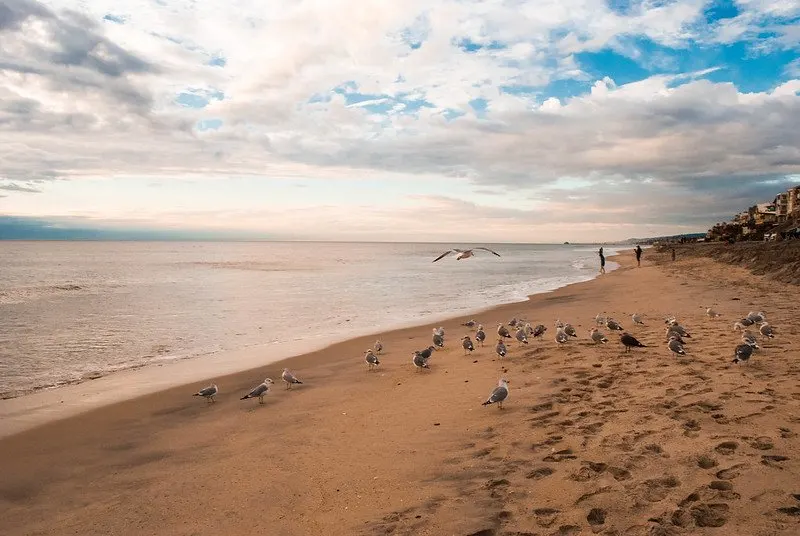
<box><xmin>0</xmin><ymin>0</ymin><xmax>800</xmax><ymax>242</ymax></box>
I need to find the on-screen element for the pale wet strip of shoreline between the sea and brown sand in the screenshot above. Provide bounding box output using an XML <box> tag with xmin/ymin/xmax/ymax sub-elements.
<box><xmin>0</xmin><ymin>256</ymin><xmax>627</xmax><ymax>440</ymax></box>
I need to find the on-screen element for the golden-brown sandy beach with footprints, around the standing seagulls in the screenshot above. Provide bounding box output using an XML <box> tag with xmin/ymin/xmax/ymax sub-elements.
<box><xmin>0</xmin><ymin>251</ymin><xmax>800</xmax><ymax>536</ymax></box>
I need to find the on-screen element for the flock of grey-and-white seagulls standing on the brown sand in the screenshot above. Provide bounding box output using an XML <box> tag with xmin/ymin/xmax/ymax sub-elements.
<box><xmin>194</xmin><ymin>306</ymin><xmax>775</xmax><ymax>409</ymax></box>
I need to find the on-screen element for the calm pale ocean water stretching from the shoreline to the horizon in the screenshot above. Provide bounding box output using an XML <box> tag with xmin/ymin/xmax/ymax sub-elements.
<box><xmin>0</xmin><ymin>242</ymin><xmax>614</xmax><ymax>398</ymax></box>
